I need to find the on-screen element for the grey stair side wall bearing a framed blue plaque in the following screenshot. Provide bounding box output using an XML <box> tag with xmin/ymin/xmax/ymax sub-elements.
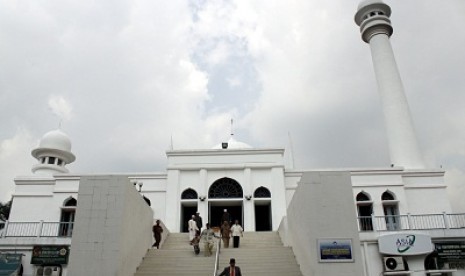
<box><xmin>278</xmin><ymin>172</ymin><xmax>363</xmax><ymax>276</ymax></box>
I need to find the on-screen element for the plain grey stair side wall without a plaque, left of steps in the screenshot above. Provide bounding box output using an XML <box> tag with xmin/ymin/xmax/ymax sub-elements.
<box><xmin>67</xmin><ymin>175</ymin><xmax>153</xmax><ymax>276</ymax></box>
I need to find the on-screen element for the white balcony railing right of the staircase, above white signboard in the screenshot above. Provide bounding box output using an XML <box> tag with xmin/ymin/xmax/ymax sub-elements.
<box><xmin>357</xmin><ymin>213</ymin><xmax>465</xmax><ymax>232</ymax></box>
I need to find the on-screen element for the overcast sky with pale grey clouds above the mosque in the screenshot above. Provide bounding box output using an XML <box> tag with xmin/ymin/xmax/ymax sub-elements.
<box><xmin>0</xmin><ymin>0</ymin><xmax>465</xmax><ymax>212</ymax></box>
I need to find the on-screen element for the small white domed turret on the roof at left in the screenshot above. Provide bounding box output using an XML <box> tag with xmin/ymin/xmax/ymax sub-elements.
<box><xmin>31</xmin><ymin>129</ymin><xmax>76</xmax><ymax>175</ymax></box>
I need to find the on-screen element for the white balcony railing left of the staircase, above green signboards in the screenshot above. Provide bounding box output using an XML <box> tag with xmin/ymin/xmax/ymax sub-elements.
<box><xmin>0</xmin><ymin>221</ymin><xmax>73</xmax><ymax>238</ymax></box>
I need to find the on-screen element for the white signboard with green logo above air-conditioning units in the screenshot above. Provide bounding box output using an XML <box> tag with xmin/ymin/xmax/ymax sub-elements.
<box><xmin>378</xmin><ymin>233</ymin><xmax>434</xmax><ymax>256</ymax></box>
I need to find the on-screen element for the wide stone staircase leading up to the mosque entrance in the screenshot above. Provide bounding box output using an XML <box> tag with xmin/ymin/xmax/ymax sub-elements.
<box><xmin>134</xmin><ymin>232</ymin><xmax>302</xmax><ymax>276</ymax></box>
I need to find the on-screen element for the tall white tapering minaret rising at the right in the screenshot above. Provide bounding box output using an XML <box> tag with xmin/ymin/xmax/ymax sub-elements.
<box><xmin>355</xmin><ymin>0</ymin><xmax>425</xmax><ymax>169</ymax></box>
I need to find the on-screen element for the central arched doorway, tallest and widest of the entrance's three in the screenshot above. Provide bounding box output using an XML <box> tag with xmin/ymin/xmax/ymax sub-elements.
<box><xmin>208</xmin><ymin>177</ymin><xmax>244</xmax><ymax>227</ymax></box>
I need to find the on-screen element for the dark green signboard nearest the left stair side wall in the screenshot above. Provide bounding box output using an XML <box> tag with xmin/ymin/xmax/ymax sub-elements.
<box><xmin>31</xmin><ymin>245</ymin><xmax>69</xmax><ymax>265</ymax></box>
